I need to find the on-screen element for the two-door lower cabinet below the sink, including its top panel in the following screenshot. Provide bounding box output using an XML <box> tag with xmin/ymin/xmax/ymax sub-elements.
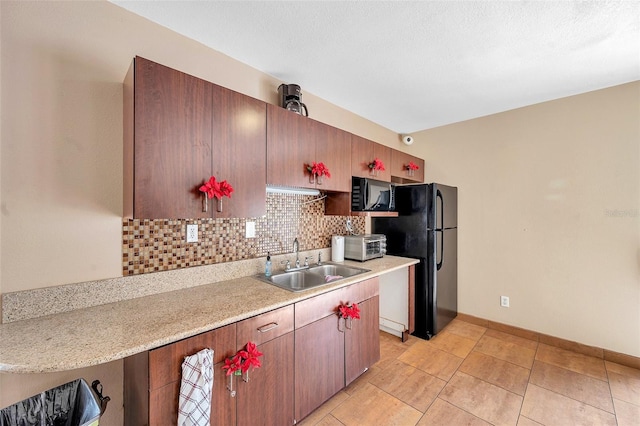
<box><xmin>295</xmin><ymin>277</ymin><xmax>380</xmax><ymax>421</ymax></box>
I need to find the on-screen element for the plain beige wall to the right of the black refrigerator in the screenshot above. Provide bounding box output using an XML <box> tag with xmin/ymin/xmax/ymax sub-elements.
<box><xmin>414</xmin><ymin>82</ymin><xmax>640</xmax><ymax>356</ymax></box>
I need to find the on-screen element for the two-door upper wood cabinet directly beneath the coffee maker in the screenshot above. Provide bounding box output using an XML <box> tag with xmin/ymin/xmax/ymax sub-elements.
<box><xmin>267</xmin><ymin>105</ymin><xmax>351</xmax><ymax>192</ymax></box>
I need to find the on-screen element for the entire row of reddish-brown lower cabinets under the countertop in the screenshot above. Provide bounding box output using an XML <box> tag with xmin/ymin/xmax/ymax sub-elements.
<box><xmin>124</xmin><ymin>277</ymin><xmax>380</xmax><ymax>426</ymax></box>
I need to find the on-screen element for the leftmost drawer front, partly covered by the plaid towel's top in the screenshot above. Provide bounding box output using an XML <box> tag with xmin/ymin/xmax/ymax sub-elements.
<box><xmin>149</xmin><ymin>324</ymin><xmax>236</xmax><ymax>390</ymax></box>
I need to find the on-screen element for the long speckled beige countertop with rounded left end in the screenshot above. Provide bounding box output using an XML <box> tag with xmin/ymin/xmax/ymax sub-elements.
<box><xmin>0</xmin><ymin>256</ymin><xmax>418</xmax><ymax>373</ymax></box>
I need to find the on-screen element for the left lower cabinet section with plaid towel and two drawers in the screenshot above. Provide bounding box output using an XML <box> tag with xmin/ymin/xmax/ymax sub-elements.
<box><xmin>124</xmin><ymin>305</ymin><xmax>294</xmax><ymax>426</ymax></box>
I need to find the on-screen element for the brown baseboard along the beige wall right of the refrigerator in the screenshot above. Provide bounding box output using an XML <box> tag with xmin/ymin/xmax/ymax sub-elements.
<box><xmin>457</xmin><ymin>313</ymin><xmax>640</xmax><ymax>370</ymax></box>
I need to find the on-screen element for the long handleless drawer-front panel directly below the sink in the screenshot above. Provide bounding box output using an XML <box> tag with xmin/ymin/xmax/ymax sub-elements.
<box><xmin>295</xmin><ymin>277</ymin><xmax>380</xmax><ymax>329</ymax></box>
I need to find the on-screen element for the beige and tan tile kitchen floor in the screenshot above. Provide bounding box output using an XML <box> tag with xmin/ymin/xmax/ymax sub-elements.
<box><xmin>300</xmin><ymin>319</ymin><xmax>640</xmax><ymax>426</ymax></box>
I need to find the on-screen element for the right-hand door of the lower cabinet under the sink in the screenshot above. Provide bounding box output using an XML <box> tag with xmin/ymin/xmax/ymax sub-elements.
<box><xmin>345</xmin><ymin>296</ymin><xmax>380</xmax><ymax>385</ymax></box>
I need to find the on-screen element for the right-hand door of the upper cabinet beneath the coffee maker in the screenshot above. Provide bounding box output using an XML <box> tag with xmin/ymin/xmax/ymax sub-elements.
<box><xmin>310</xmin><ymin>120</ymin><xmax>351</xmax><ymax>192</ymax></box>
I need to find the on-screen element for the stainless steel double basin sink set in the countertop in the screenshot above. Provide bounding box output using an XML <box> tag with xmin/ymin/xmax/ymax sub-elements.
<box><xmin>258</xmin><ymin>262</ymin><xmax>371</xmax><ymax>292</ymax></box>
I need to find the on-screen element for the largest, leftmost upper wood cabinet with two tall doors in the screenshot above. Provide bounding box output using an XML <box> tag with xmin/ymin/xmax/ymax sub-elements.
<box><xmin>124</xmin><ymin>57</ymin><xmax>266</xmax><ymax>219</ymax></box>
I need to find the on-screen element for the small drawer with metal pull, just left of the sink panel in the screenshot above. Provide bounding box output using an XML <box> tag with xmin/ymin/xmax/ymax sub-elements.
<box><xmin>236</xmin><ymin>305</ymin><xmax>293</xmax><ymax>350</ymax></box>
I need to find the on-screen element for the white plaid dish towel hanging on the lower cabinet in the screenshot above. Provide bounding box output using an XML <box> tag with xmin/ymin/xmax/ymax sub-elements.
<box><xmin>178</xmin><ymin>349</ymin><xmax>213</xmax><ymax>426</ymax></box>
